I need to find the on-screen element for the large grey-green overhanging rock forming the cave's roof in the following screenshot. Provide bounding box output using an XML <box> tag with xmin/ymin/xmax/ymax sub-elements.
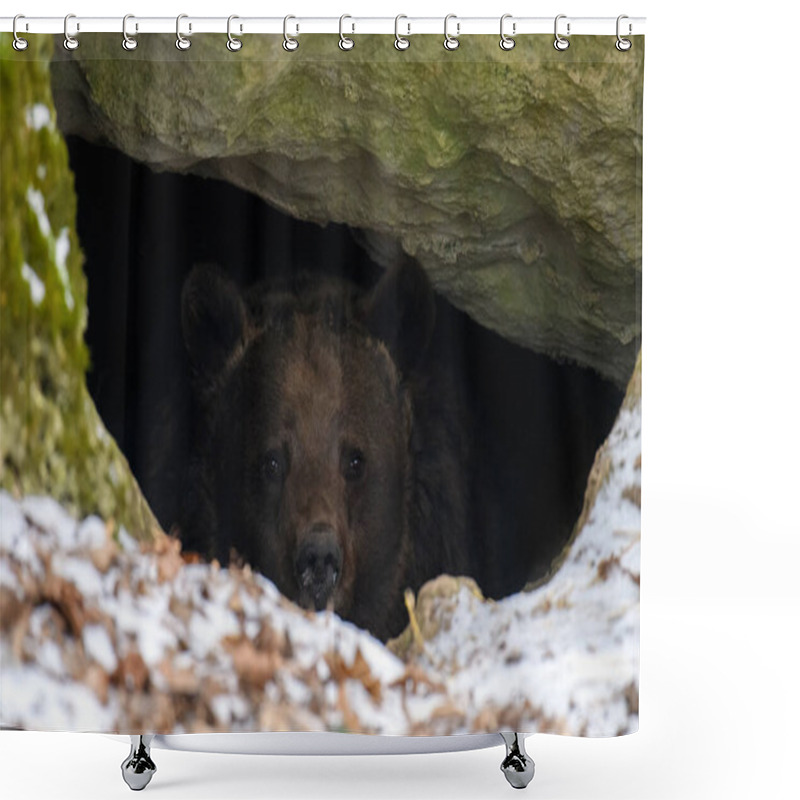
<box><xmin>53</xmin><ymin>35</ymin><xmax>644</xmax><ymax>386</ymax></box>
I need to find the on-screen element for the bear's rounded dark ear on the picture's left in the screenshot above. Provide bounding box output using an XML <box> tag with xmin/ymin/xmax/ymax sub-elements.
<box><xmin>181</xmin><ymin>264</ymin><xmax>247</xmax><ymax>380</ymax></box>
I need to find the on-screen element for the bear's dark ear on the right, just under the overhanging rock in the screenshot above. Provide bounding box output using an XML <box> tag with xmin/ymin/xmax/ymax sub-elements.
<box><xmin>363</xmin><ymin>258</ymin><xmax>436</xmax><ymax>375</ymax></box>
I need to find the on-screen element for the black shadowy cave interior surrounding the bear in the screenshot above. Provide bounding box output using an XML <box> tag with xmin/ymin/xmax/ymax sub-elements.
<box><xmin>67</xmin><ymin>136</ymin><xmax>623</xmax><ymax>598</ymax></box>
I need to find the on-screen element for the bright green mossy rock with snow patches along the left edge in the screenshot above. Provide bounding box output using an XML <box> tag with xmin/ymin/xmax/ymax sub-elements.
<box><xmin>0</xmin><ymin>34</ymin><xmax>159</xmax><ymax>539</ymax></box>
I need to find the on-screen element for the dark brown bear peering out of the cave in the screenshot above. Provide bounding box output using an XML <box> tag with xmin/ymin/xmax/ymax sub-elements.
<box><xmin>179</xmin><ymin>260</ymin><xmax>474</xmax><ymax>640</ymax></box>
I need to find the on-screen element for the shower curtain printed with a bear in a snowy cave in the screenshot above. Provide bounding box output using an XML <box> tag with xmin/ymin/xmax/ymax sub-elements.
<box><xmin>0</xmin><ymin>23</ymin><xmax>644</xmax><ymax>736</ymax></box>
